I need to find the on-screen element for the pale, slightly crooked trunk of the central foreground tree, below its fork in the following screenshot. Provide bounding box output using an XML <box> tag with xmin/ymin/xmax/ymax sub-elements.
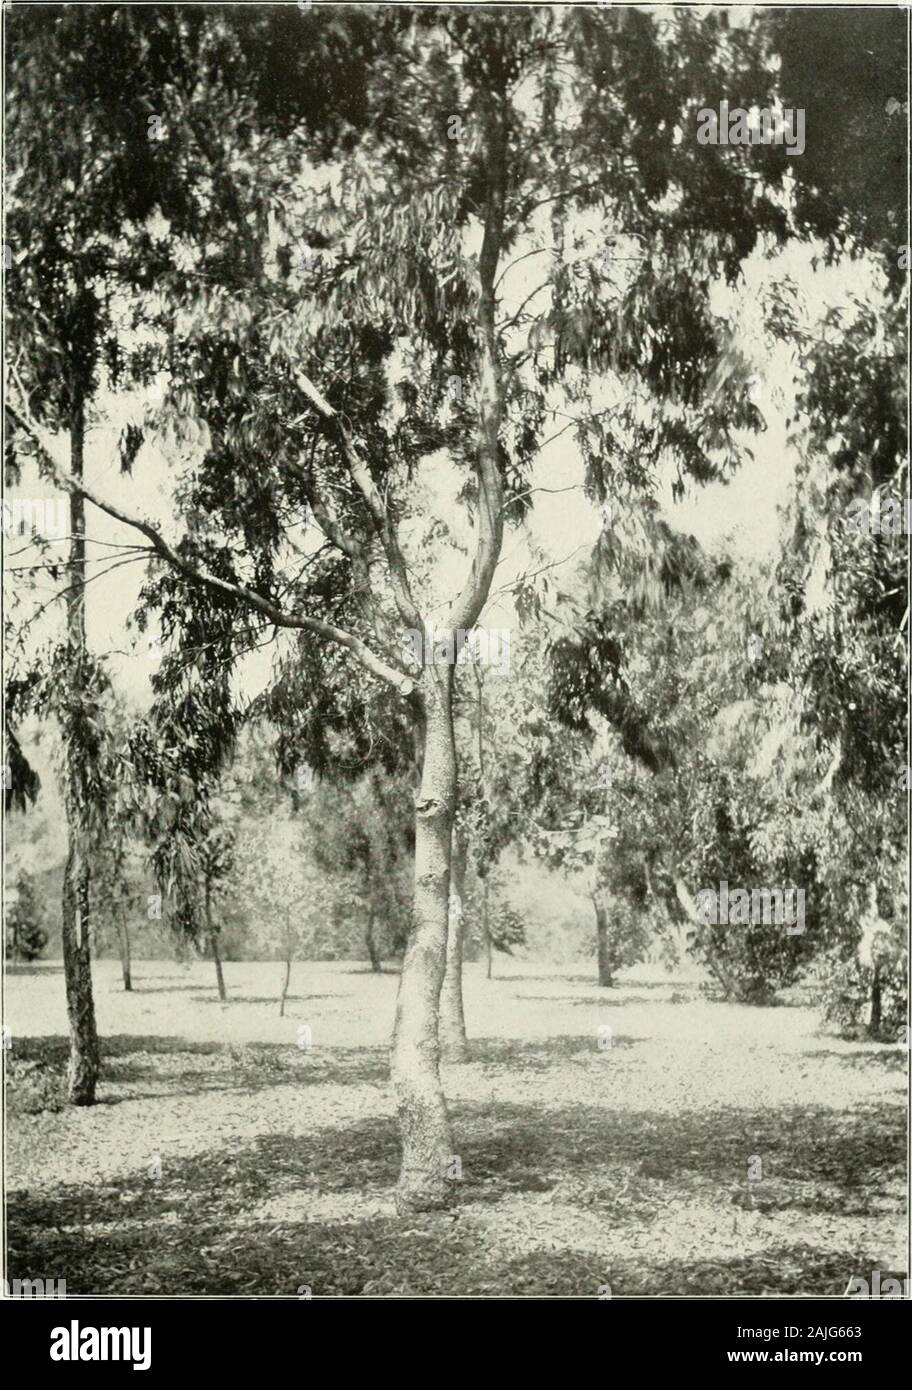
<box><xmin>391</xmin><ymin>664</ymin><xmax>456</xmax><ymax>1212</ymax></box>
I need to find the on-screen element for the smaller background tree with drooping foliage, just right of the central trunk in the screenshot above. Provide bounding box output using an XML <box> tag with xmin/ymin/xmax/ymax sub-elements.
<box><xmin>485</xmin><ymin>619</ymin><xmax>660</xmax><ymax>987</ymax></box>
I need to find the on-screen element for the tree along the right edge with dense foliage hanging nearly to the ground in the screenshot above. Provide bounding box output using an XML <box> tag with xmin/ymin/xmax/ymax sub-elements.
<box><xmin>770</xmin><ymin>8</ymin><xmax>911</xmax><ymax>1037</ymax></box>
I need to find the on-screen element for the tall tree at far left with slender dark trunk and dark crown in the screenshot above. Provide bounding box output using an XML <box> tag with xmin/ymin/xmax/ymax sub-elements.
<box><xmin>4</xmin><ymin>7</ymin><xmax>218</xmax><ymax>1105</ymax></box>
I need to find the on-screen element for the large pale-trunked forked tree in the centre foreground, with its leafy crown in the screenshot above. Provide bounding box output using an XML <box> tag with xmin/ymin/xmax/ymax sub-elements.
<box><xmin>13</xmin><ymin>7</ymin><xmax>787</xmax><ymax>1209</ymax></box>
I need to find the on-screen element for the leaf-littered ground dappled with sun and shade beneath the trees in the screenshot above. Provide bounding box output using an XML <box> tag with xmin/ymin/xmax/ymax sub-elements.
<box><xmin>6</xmin><ymin>962</ymin><xmax>908</xmax><ymax>1297</ymax></box>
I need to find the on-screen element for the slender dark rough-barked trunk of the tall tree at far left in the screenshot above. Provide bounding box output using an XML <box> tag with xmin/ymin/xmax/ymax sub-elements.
<box><xmin>61</xmin><ymin>398</ymin><xmax>99</xmax><ymax>1105</ymax></box>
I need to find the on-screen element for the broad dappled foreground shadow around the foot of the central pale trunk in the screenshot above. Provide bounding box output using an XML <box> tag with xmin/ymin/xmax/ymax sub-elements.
<box><xmin>7</xmin><ymin>1089</ymin><xmax>904</xmax><ymax>1297</ymax></box>
